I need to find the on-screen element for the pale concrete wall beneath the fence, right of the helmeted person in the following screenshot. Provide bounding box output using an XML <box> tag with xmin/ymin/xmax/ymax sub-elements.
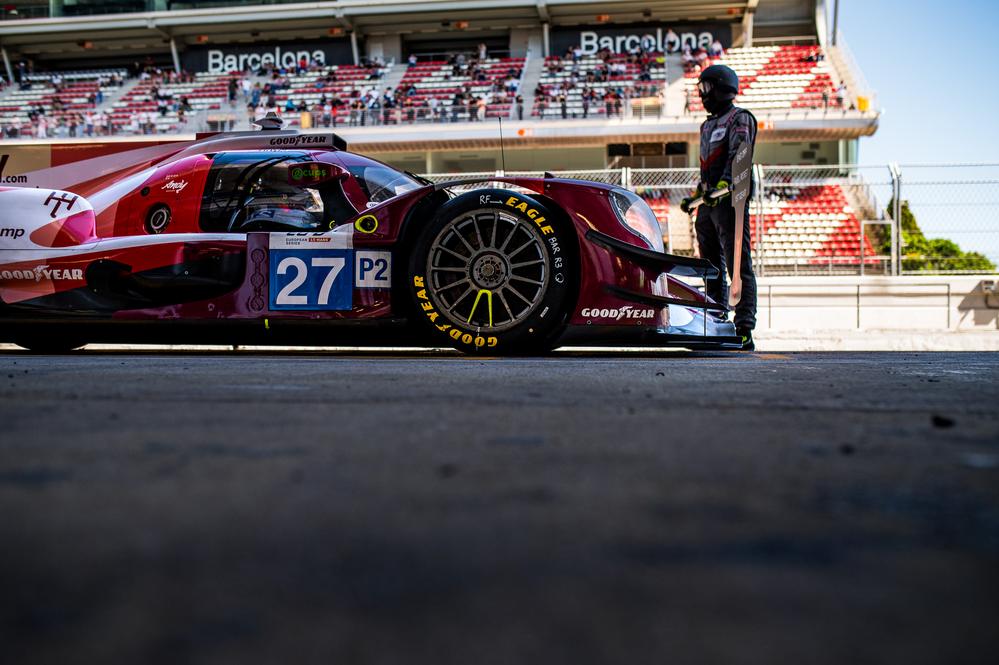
<box><xmin>757</xmin><ymin>275</ymin><xmax>999</xmax><ymax>331</ymax></box>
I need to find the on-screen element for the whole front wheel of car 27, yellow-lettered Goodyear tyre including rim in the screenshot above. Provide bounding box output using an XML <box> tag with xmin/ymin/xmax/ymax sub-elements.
<box><xmin>407</xmin><ymin>189</ymin><xmax>578</xmax><ymax>354</ymax></box>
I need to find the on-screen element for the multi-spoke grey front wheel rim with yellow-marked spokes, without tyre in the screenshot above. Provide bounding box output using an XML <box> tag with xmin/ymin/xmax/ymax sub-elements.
<box><xmin>427</xmin><ymin>209</ymin><xmax>550</xmax><ymax>332</ymax></box>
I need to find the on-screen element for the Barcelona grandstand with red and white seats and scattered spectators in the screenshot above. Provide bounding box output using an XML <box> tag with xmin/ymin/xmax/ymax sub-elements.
<box><xmin>0</xmin><ymin>0</ymin><xmax>883</xmax><ymax>270</ymax></box>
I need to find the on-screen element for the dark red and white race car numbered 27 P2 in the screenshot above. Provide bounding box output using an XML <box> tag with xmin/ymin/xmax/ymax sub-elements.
<box><xmin>0</xmin><ymin>123</ymin><xmax>740</xmax><ymax>354</ymax></box>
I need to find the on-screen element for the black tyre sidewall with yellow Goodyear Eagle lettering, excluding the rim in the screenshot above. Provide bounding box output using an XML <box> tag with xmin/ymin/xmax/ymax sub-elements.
<box><xmin>407</xmin><ymin>189</ymin><xmax>578</xmax><ymax>354</ymax></box>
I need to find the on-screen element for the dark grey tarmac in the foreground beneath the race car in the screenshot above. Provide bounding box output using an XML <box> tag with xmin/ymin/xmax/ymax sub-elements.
<box><xmin>0</xmin><ymin>351</ymin><xmax>999</xmax><ymax>665</ymax></box>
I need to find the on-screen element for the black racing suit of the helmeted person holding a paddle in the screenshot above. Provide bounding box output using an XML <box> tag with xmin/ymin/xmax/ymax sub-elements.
<box><xmin>694</xmin><ymin>106</ymin><xmax>756</xmax><ymax>333</ymax></box>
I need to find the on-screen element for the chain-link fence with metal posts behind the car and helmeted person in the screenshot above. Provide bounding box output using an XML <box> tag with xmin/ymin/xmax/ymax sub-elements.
<box><xmin>426</xmin><ymin>164</ymin><xmax>999</xmax><ymax>275</ymax></box>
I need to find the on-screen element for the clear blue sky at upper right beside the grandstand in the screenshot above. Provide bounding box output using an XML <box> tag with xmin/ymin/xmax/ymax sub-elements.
<box><xmin>829</xmin><ymin>0</ymin><xmax>999</xmax><ymax>164</ymax></box>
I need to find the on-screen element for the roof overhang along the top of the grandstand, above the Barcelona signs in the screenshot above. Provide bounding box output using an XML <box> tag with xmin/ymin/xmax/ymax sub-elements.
<box><xmin>0</xmin><ymin>0</ymin><xmax>788</xmax><ymax>60</ymax></box>
